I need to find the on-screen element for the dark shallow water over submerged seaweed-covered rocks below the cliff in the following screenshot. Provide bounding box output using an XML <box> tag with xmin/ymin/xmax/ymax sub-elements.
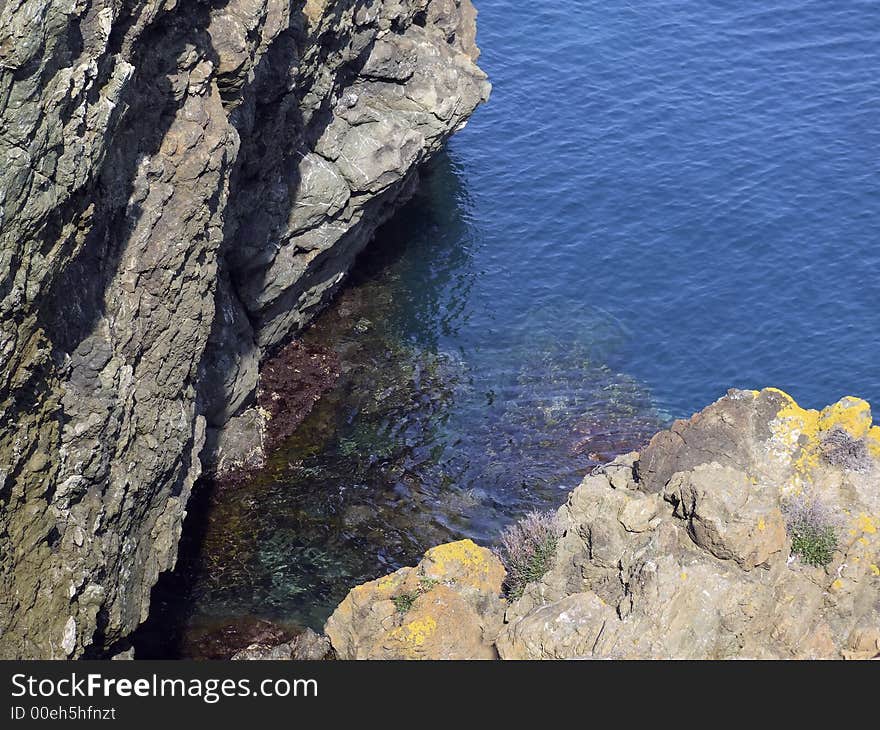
<box><xmin>135</xmin><ymin>154</ymin><xmax>664</xmax><ymax>658</ymax></box>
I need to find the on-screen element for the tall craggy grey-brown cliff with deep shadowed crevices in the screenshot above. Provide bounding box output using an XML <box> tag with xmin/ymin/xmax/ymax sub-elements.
<box><xmin>0</xmin><ymin>0</ymin><xmax>489</xmax><ymax>657</ymax></box>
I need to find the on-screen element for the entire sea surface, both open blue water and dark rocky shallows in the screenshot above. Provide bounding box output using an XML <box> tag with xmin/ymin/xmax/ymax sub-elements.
<box><xmin>136</xmin><ymin>0</ymin><xmax>880</xmax><ymax>653</ymax></box>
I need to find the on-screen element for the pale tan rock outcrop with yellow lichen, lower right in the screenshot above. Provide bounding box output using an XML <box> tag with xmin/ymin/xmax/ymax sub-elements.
<box><xmin>327</xmin><ymin>389</ymin><xmax>880</xmax><ymax>659</ymax></box>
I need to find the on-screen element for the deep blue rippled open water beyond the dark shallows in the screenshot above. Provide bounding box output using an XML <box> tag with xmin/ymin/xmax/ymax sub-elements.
<box><xmin>460</xmin><ymin>0</ymin><xmax>880</xmax><ymax>417</ymax></box>
